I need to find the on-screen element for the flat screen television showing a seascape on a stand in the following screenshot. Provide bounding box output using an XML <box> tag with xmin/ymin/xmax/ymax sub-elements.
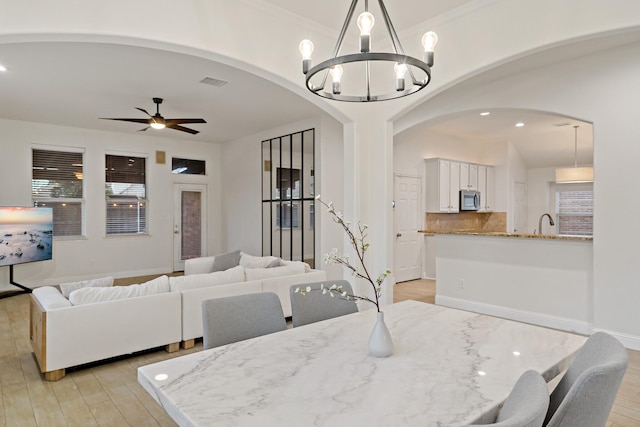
<box><xmin>0</xmin><ymin>207</ymin><xmax>53</xmax><ymax>267</ymax></box>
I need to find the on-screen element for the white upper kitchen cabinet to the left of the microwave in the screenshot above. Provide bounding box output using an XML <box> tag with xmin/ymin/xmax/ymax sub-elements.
<box><xmin>425</xmin><ymin>159</ymin><xmax>460</xmax><ymax>213</ymax></box>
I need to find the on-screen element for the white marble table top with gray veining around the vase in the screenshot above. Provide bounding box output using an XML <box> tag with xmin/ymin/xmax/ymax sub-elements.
<box><xmin>138</xmin><ymin>301</ymin><xmax>585</xmax><ymax>427</ymax></box>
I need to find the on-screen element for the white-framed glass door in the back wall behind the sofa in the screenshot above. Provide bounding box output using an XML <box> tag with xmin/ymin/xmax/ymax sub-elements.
<box><xmin>173</xmin><ymin>184</ymin><xmax>207</xmax><ymax>271</ymax></box>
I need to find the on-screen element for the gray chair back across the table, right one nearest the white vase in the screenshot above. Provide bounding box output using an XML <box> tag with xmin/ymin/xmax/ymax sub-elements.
<box><xmin>289</xmin><ymin>280</ymin><xmax>358</xmax><ymax>327</ymax></box>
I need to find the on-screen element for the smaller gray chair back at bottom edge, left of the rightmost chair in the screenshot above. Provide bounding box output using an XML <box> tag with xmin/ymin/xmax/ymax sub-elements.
<box><xmin>468</xmin><ymin>370</ymin><xmax>549</xmax><ymax>427</ymax></box>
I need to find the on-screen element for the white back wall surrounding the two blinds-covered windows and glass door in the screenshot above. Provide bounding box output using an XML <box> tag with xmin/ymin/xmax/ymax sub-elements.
<box><xmin>0</xmin><ymin>119</ymin><xmax>220</xmax><ymax>286</ymax></box>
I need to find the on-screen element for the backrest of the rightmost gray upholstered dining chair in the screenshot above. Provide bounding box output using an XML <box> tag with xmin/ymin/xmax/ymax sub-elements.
<box><xmin>545</xmin><ymin>332</ymin><xmax>629</xmax><ymax>427</ymax></box>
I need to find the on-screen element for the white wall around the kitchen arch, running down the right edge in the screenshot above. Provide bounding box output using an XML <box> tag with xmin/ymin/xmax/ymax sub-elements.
<box><xmin>392</xmin><ymin>39</ymin><xmax>640</xmax><ymax>348</ymax></box>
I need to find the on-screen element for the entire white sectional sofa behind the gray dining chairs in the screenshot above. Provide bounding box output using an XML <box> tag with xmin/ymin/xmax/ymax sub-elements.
<box><xmin>30</xmin><ymin>254</ymin><xmax>326</xmax><ymax>380</ymax></box>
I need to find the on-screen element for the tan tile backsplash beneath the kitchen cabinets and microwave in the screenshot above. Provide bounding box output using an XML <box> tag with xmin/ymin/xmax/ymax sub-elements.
<box><xmin>425</xmin><ymin>212</ymin><xmax>507</xmax><ymax>233</ymax></box>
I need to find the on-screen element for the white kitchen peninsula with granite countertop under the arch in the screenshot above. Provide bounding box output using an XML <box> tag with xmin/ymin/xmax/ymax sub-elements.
<box><xmin>432</xmin><ymin>231</ymin><xmax>594</xmax><ymax>334</ymax></box>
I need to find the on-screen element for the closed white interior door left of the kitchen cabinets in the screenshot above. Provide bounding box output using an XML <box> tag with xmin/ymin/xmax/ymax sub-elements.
<box><xmin>393</xmin><ymin>175</ymin><xmax>423</xmax><ymax>282</ymax></box>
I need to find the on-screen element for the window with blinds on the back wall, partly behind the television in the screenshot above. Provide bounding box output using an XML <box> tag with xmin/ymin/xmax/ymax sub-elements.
<box><xmin>31</xmin><ymin>149</ymin><xmax>84</xmax><ymax>237</ymax></box>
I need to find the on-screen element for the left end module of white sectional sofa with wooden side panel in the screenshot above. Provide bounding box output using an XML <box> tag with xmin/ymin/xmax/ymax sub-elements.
<box><xmin>29</xmin><ymin>276</ymin><xmax>182</xmax><ymax>381</ymax></box>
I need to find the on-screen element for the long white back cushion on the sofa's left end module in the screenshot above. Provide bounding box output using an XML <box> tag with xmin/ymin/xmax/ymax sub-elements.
<box><xmin>69</xmin><ymin>276</ymin><xmax>171</xmax><ymax>305</ymax></box>
